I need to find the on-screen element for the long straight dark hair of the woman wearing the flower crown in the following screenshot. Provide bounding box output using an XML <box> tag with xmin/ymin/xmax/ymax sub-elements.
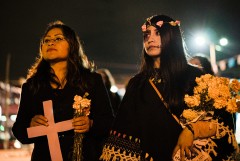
<box><xmin>141</xmin><ymin>15</ymin><xmax>188</xmax><ymax>113</ymax></box>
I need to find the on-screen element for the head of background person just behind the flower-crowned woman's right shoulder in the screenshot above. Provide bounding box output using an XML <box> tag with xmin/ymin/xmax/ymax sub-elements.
<box><xmin>189</xmin><ymin>54</ymin><xmax>214</xmax><ymax>75</ymax></box>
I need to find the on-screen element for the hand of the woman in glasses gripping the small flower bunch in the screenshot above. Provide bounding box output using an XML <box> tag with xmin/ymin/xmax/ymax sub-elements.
<box><xmin>73</xmin><ymin>116</ymin><xmax>92</xmax><ymax>133</ymax></box>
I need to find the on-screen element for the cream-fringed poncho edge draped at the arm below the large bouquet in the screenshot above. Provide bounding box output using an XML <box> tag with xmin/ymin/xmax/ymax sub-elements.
<box><xmin>178</xmin><ymin>119</ymin><xmax>239</xmax><ymax>161</ymax></box>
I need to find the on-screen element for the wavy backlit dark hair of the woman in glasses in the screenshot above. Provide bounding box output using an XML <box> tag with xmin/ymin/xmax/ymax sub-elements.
<box><xmin>27</xmin><ymin>21</ymin><xmax>92</xmax><ymax>92</ymax></box>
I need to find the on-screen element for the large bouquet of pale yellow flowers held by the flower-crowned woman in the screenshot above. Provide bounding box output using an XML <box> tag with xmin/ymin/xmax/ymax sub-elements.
<box><xmin>181</xmin><ymin>74</ymin><xmax>240</xmax><ymax>125</ymax></box>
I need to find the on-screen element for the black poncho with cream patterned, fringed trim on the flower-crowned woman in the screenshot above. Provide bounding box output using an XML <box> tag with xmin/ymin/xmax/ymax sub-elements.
<box><xmin>100</xmin><ymin>68</ymin><xmax>237</xmax><ymax>161</ymax></box>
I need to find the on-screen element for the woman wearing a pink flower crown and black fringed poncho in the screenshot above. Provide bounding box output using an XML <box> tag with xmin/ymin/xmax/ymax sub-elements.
<box><xmin>100</xmin><ymin>15</ymin><xmax>237</xmax><ymax>161</ymax></box>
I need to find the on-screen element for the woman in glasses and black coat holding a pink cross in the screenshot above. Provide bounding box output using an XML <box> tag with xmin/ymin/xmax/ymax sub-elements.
<box><xmin>12</xmin><ymin>21</ymin><xmax>113</xmax><ymax>161</ymax></box>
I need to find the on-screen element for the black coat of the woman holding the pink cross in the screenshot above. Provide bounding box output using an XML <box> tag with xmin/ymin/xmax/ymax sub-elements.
<box><xmin>12</xmin><ymin>73</ymin><xmax>113</xmax><ymax>161</ymax></box>
